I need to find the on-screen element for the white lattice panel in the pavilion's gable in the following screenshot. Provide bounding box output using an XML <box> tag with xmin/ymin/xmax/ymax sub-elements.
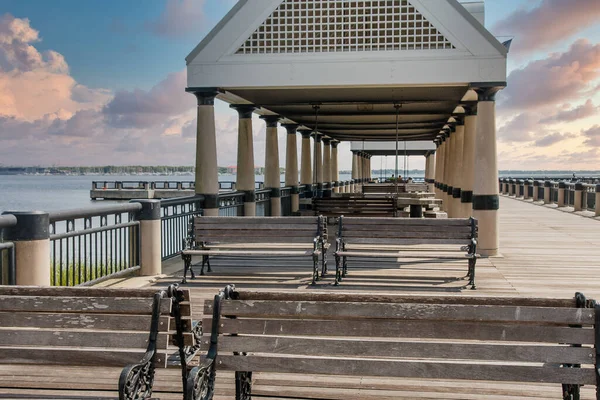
<box><xmin>236</xmin><ymin>0</ymin><xmax>455</xmax><ymax>54</ymax></box>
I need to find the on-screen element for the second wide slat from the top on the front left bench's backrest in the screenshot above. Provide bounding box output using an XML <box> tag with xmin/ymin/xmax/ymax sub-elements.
<box><xmin>0</xmin><ymin>312</ymin><xmax>169</xmax><ymax>332</ymax></box>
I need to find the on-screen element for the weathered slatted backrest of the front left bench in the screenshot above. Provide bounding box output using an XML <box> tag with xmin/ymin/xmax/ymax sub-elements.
<box><xmin>0</xmin><ymin>286</ymin><xmax>195</xmax><ymax>367</ymax></box>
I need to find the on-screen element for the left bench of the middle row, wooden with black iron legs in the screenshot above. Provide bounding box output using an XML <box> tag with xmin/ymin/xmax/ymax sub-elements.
<box><xmin>181</xmin><ymin>216</ymin><xmax>329</xmax><ymax>284</ymax></box>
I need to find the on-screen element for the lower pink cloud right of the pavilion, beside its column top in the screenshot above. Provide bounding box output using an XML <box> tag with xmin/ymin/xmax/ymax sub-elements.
<box><xmin>499</xmin><ymin>39</ymin><xmax>600</xmax><ymax>110</ymax></box>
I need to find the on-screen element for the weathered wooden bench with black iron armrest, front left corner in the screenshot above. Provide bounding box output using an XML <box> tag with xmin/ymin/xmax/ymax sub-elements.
<box><xmin>0</xmin><ymin>286</ymin><xmax>201</xmax><ymax>399</ymax></box>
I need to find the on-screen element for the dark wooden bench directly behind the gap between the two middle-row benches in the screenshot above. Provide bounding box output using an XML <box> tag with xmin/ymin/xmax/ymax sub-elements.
<box><xmin>313</xmin><ymin>196</ymin><xmax>396</xmax><ymax>217</ymax></box>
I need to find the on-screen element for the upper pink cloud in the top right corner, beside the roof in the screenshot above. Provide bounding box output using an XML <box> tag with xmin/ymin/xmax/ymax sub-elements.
<box><xmin>492</xmin><ymin>0</ymin><xmax>600</xmax><ymax>53</ymax></box>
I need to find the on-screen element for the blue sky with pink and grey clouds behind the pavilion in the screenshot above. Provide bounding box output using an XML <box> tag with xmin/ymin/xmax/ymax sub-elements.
<box><xmin>0</xmin><ymin>0</ymin><xmax>600</xmax><ymax>170</ymax></box>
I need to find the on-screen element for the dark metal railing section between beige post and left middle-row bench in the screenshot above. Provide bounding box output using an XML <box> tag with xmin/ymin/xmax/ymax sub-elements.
<box><xmin>160</xmin><ymin>196</ymin><xmax>204</xmax><ymax>260</ymax></box>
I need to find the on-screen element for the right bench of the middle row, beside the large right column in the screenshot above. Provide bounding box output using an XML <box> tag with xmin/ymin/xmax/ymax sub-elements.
<box><xmin>334</xmin><ymin>216</ymin><xmax>477</xmax><ymax>289</ymax></box>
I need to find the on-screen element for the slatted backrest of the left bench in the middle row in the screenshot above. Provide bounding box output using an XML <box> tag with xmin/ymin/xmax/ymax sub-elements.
<box><xmin>192</xmin><ymin>217</ymin><xmax>324</xmax><ymax>245</ymax></box>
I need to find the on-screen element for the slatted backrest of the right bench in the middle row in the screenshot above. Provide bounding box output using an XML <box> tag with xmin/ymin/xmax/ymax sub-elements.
<box><xmin>338</xmin><ymin>217</ymin><xmax>477</xmax><ymax>245</ymax></box>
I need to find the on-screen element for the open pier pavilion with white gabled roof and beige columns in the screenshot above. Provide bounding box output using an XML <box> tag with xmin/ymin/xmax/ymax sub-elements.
<box><xmin>186</xmin><ymin>0</ymin><xmax>507</xmax><ymax>256</ymax></box>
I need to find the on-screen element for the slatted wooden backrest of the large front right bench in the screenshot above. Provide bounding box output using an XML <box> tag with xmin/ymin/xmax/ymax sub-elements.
<box><xmin>201</xmin><ymin>292</ymin><xmax>598</xmax><ymax>390</ymax></box>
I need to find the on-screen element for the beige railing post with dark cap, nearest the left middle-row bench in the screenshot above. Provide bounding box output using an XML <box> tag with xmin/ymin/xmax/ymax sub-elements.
<box><xmin>131</xmin><ymin>199</ymin><xmax>162</xmax><ymax>276</ymax></box>
